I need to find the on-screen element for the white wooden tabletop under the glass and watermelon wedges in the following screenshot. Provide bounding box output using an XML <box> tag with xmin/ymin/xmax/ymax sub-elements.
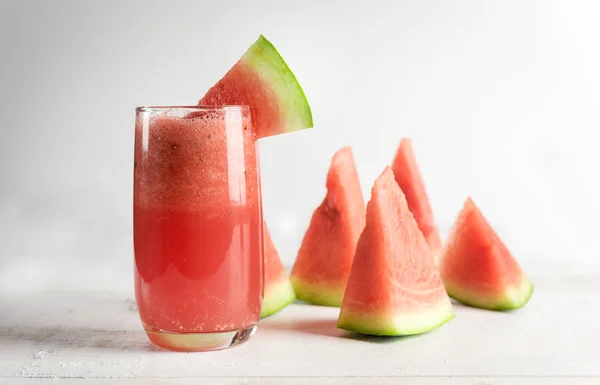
<box><xmin>0</xmin><ymin>275</ymin><xmax>600</xmax><ymax>385</ymax></box>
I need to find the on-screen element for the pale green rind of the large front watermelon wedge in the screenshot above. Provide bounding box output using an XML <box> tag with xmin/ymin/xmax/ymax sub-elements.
<box><xmin>337</xmin><ymin>297</ymin><xmax>455</xmax><ymax>337</ymax></box>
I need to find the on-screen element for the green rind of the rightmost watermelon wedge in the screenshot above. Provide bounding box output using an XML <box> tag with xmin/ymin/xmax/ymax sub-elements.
<box><xmin>444</xmin><ymin>277</ymin><xmax>534</xmax><ymax>311</ymax></box>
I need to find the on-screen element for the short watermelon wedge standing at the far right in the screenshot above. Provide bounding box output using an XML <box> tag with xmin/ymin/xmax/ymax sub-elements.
<box><xmin>440</xmin><ymin>198</ymin><xmax>533</xmax><ymax>310</ymax></box>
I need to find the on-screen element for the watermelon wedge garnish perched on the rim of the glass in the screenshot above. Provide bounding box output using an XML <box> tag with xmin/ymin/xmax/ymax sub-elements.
<box><xmin>198</xmin><ymin>35</ymin><xmax>313</xmax><ymax>138</ymax></box>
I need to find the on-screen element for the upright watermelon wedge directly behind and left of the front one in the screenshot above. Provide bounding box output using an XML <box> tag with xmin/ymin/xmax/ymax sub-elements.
<box><xmin>291</xmin><ymin>147</ymin><xmax>365</xmax><ymax>306</ymax></box>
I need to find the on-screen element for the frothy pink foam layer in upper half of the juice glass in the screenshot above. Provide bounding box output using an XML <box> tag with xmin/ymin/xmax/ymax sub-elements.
<box><xmin>134</xmin><ymin>111</ymin><xmax>258</xmax><ymax>209</ymax></box>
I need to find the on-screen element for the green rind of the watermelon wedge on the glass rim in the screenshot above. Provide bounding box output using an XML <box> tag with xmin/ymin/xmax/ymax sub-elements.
<box><xmin>241</xmin><ymin>35</ymin><xmax>313</xmax><ymax>132</ymax></box>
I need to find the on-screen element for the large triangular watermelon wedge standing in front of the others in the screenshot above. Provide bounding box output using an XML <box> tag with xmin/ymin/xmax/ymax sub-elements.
<box><xmin>338</xmin><ymin>167</ymin><xmax>454</xmax><ymax>336</ymax></box>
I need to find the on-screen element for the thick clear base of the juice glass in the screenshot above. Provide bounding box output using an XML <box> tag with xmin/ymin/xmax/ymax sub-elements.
<box><xmin>145</xmin><ymin>325</ymin><xmax>256</xmax><ymax>352</ymax></box>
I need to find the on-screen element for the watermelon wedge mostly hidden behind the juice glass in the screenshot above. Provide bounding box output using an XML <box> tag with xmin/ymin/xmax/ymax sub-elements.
<box><xmin>260</xmin><ymin>224</ymin><xmax>296</xmax><ymax>318</ymax></box>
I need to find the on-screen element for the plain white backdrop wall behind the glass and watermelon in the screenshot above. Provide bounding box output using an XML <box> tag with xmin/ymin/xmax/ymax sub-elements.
<box><xmin>0</xmin><ymin>0</ymin><xmax>600</xmax><ymax>292</ymax></box>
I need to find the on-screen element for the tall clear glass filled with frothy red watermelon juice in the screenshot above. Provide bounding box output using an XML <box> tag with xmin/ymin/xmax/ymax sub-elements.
<box><xmin>133</xmin><ymin>106</ymin><xmax>263</xmax><ymax>351</ymax></box>
